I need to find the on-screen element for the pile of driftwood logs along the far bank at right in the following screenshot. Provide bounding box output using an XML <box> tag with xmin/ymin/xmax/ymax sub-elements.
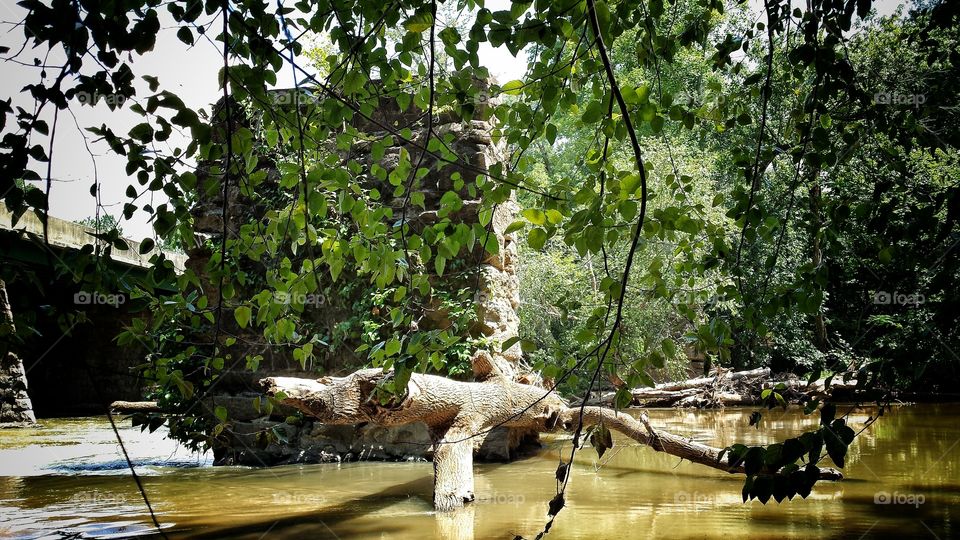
<box><xmin>591</xmin><ymin>368</ymin><xmax>857</xmax><ymax>408</ymax></box>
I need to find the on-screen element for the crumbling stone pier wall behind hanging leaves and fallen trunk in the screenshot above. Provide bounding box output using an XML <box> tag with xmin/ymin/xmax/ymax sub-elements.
<box><xmin>187</xmin><ymin>84</ymin><xmax>536</xmax><ymax>465</ymax></box>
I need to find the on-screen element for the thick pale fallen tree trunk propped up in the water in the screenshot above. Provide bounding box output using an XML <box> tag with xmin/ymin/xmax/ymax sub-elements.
<box><xmin>261</xmin><ymin>352</ymin><xmax>842</xmax><ymax>511</ymax></box>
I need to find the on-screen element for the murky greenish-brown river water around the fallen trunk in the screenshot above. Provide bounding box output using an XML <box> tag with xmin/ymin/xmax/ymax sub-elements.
<box><xmin>0</xmin><ymin>405</ymin><xmax>960</xmax><ymax>540</ymax></box>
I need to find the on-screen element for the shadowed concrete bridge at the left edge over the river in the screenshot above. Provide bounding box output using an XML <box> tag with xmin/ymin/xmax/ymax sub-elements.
<box><xmin>0</xmin><ymin>208</ymin><xmax>187</xmax><ymax>423</ymax></box>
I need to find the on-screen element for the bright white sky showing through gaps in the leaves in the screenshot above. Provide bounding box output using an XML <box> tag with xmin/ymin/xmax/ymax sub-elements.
<box><xmin>0</xmin><ymin>0</ymin><xmax>900</xmax><ymax>240</ymax></box>
